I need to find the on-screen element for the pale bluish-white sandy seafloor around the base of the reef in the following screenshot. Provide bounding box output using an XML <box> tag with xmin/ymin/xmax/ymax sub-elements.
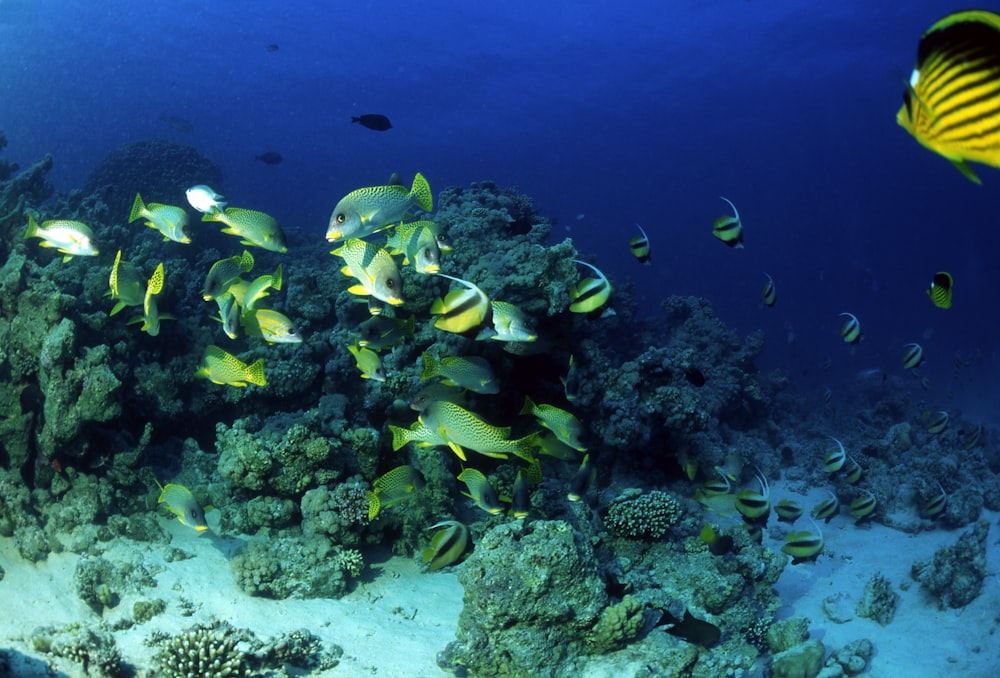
<box><xmin>0</xmin><ymin>481</ymin><xmax>1000</xmax><ymax>678</ymax></box>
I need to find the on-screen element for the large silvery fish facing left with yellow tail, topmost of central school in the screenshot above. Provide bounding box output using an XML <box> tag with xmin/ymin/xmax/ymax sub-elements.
<box><xmin>326</xmin><ymin>172</ymin><xmax>434</xmax><ymax>242</ymax></box>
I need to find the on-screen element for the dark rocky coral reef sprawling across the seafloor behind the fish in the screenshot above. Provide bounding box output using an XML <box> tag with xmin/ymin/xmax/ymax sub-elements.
<box><xmin>0</xmin><ymin>129</ymin><xmax>1000</xmax><ymax>676</ymax></box>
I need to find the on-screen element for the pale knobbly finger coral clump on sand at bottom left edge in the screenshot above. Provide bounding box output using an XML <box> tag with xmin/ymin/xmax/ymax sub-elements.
<box><xmin>156</xmin><ymin>626</ymin><xmax>246</xmax><ymax>678</ymax></box>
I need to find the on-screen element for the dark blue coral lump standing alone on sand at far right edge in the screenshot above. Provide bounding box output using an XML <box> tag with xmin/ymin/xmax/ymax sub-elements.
<box><xmin>912</xmin><ymin>520</ymin><xmax>990</xmax><ymax>610</ymax></box>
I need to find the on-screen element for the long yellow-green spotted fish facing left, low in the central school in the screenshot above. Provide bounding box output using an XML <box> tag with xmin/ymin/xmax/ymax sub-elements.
<box><xmin>419</xmin><ymin>400</ymin><xmax>534</xmax><ymax>461</ymax></box>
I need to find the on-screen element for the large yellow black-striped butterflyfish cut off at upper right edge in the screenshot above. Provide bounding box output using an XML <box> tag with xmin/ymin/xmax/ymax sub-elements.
<box><xmin>896</xmin><ymin>10</ymin><xmax>1000</xmax><ymax>184</ymax></box>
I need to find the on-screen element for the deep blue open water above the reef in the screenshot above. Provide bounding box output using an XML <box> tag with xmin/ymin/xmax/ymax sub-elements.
<box><xmin>0</xmin><ymin>0</ymin><xmax>1000</xmax><ymax>420</ymax></box>
